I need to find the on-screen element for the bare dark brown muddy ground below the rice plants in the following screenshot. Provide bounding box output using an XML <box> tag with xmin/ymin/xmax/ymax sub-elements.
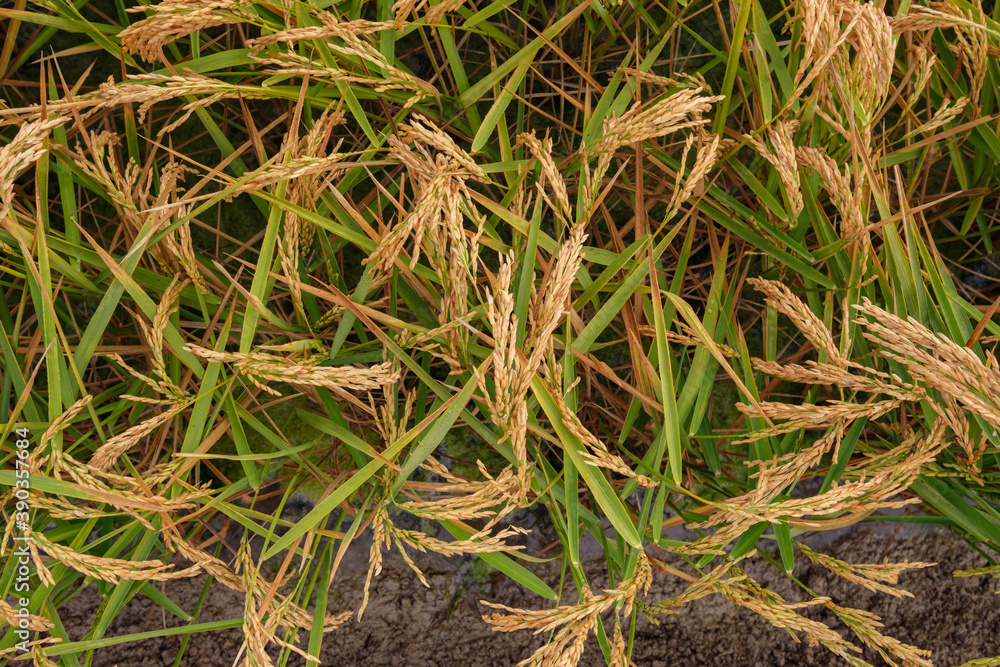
<box><xmin>52</xmin><ymin>524</ymin><xmax>1000</xmax><ymax>667</ymax></box>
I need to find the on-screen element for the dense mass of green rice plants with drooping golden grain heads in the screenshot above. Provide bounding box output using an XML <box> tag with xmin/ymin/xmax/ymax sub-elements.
<box><xmin>0</xmin><ymin>0</ymin><xmax>1000</xmax><ymax>667</ymax></box>
